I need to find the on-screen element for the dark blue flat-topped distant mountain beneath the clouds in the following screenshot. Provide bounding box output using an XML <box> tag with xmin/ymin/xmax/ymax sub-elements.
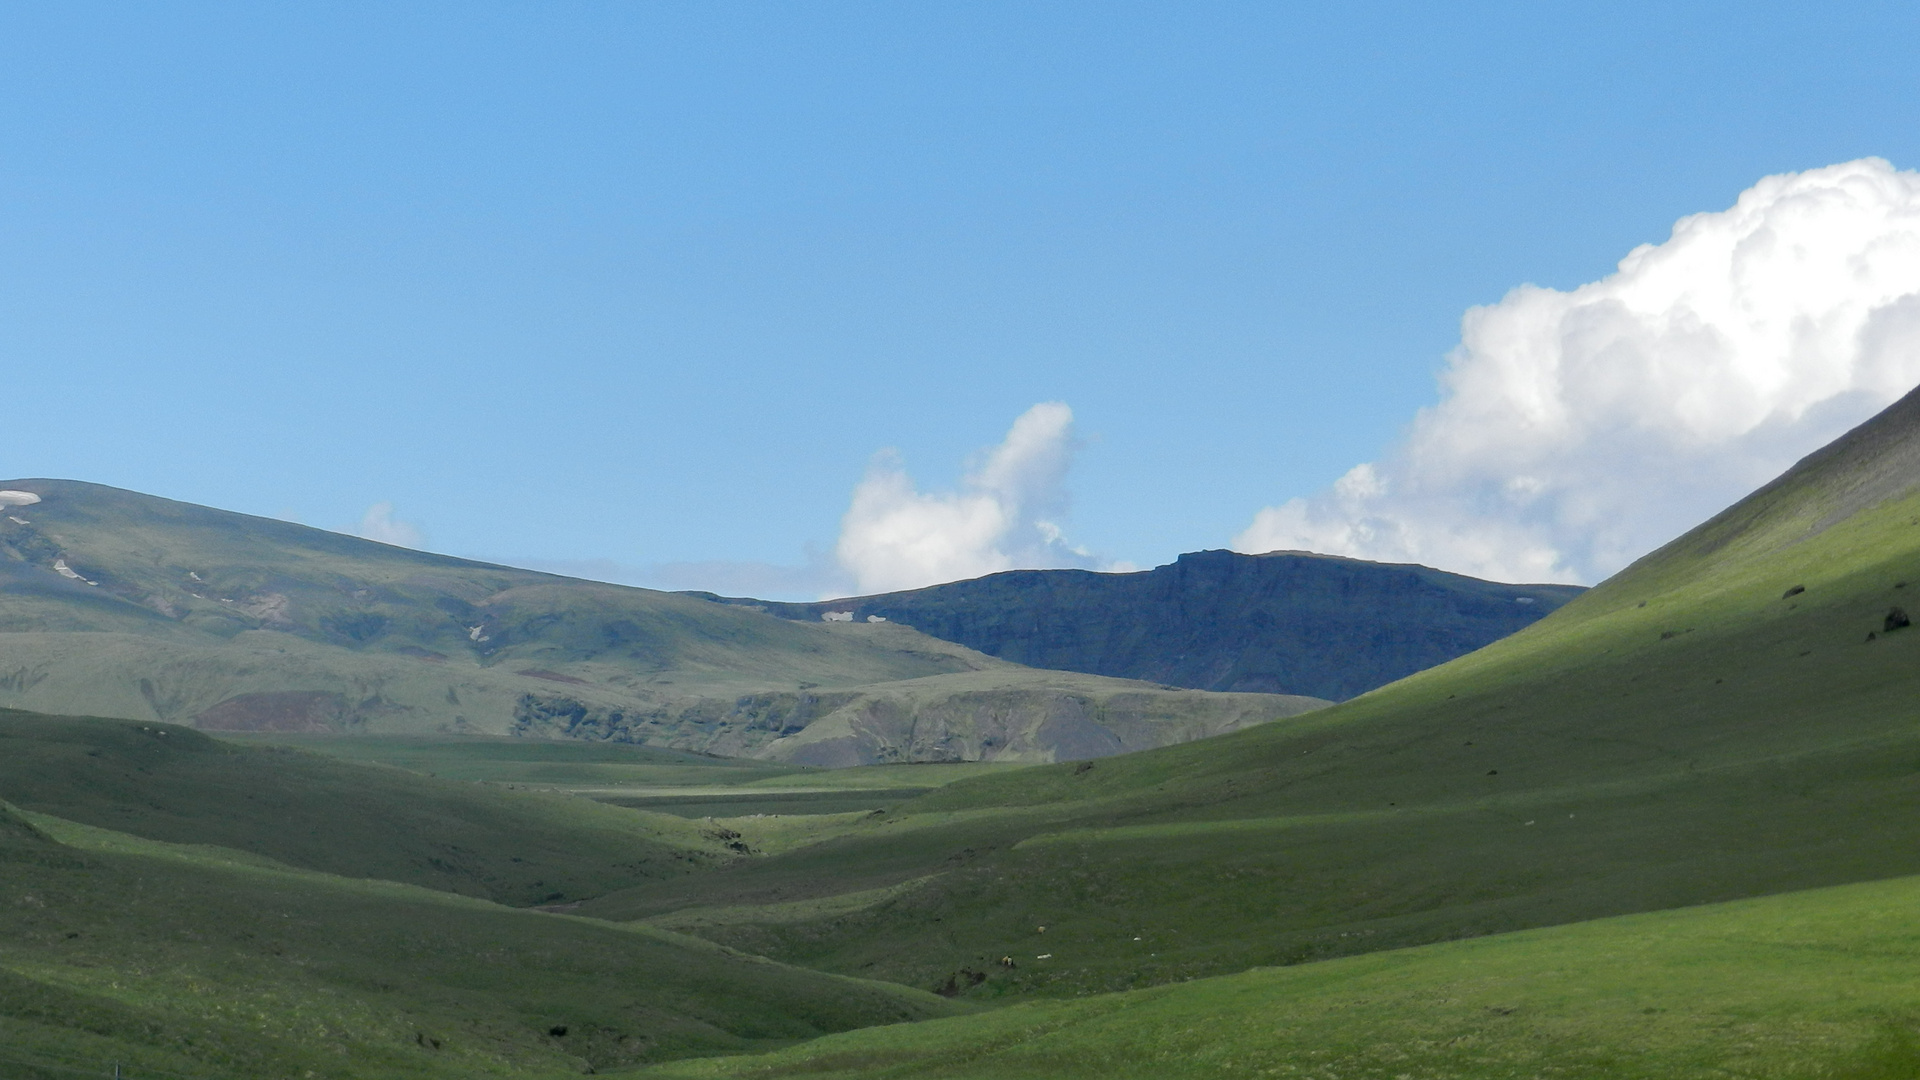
<box><xmin>689</xmin><ymin>552</ymin><xmax>1586</xmax><ymax>701</ymax></box>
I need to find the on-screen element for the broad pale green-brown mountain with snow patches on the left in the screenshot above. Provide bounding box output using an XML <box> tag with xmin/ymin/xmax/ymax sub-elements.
<box><xmin>0</xmin><ymin>480</ymin><xmax>1319</xmax><ymax>765</ymax></box>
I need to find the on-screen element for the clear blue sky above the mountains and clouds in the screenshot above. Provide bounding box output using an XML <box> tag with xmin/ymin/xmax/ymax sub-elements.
<box><xmin>0</xmin><ymin>2</ymin><xmax>1920</xmax><ymax>594</ymax></box>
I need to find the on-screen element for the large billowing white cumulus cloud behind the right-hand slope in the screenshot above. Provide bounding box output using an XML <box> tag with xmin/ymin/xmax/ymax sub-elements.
<box><xmin>1235</xmin><ymin>158</ymin><xmax>1920</xmax><ymax>582</ymax></box>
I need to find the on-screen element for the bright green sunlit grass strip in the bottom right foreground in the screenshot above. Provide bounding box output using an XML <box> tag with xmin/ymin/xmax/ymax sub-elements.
<box><xmin>641</xmin><ymin>878</ymin><xmax>1920</xmax><ymax>1080</ymax></box>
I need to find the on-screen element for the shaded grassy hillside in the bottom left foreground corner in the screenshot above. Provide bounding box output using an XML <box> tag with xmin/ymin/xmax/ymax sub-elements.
<box><xmin>0</xmin><ymin>809</ymin><xmax>952</xmax><ymax>1080</ymax></box>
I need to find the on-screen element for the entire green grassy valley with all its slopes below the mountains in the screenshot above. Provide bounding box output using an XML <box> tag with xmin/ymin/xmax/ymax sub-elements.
<box><xmin>18</xmin><ymin>386</ymin><xmax>1920</xmax><ymax>1080</ymax></box>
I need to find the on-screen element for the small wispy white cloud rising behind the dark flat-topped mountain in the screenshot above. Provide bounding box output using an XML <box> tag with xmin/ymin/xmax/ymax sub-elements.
<box><xmin>835</xmin><ymin>402</ymin><xmax>1091</xmax><ymax>594</ymax></box>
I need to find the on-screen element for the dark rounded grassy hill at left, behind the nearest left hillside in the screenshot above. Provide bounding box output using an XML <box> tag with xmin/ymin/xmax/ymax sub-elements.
<box><xmin>0</xmin><ymin>713</ymin><xmax>735</xmax><ymax>905</ymax></box>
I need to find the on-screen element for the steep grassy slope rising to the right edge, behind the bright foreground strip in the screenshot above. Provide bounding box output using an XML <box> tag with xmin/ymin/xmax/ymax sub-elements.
<box><xmin>582</xmin><ymin>382</ymin><xmax>1920</xmax><ymax>997</ymax></box>
